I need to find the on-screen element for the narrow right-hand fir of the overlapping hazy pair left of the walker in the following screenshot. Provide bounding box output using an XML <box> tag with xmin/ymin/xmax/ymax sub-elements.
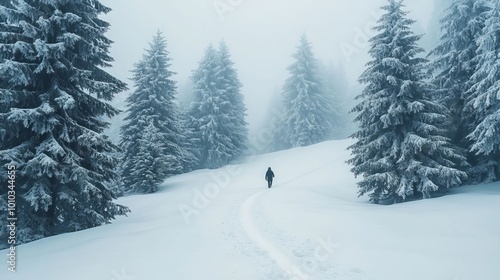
<box><xmin>217</xmin><ymin>41</ymin><xmax>248</xmax><ymax>160</ymax></box>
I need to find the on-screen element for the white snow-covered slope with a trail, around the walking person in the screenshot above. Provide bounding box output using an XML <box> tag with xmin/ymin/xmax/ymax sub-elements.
<box><xmin>0</xmin><ymin>140</ymin><xmax>500</xmax><ymax>280</ymax></box>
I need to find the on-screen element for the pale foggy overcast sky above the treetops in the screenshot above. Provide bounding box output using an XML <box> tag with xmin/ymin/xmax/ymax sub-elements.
<box><xmin>102</xmin><ymin>0</ymin><xmax>434</xmax><ymax>136</ymax></box>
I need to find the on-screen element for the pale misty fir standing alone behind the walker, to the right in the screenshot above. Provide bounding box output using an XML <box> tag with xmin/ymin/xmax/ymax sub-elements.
<box><xmin>282</xmin><ymin>34</ymin><xmax>334</xmax><ymax>148</ymax></box>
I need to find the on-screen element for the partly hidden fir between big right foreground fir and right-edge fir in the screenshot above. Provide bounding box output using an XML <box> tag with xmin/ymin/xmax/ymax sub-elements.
<box><xmin>429</xmin><ymin>0</ymin><xmax>489</xmax><ymax>180</ymax></box>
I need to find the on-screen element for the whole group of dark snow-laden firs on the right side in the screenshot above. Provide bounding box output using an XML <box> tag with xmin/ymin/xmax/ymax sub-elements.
<box><xmin>349</xmin><ymin>0</ymin><xmax>500</xmax><ymax>203</ymax></box>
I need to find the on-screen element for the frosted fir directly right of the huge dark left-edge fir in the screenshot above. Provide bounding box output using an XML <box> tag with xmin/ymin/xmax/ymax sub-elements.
<box><xmin>120</xmin><ymin>32</ymin><xmax>190</xmax><ymax>193</ymax></box>
